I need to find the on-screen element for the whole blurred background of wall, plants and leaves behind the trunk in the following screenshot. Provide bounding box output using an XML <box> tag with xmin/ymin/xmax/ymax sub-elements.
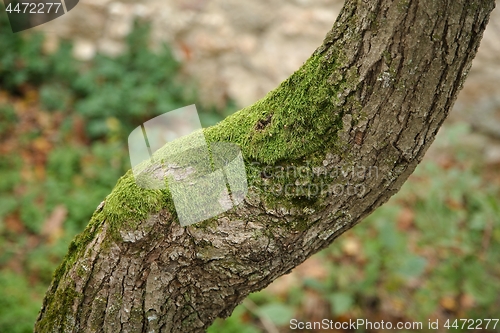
<box><xmin>0</xmin><ymin>0</ymin><xmax>500</xmax><ymax>333</ymax></box>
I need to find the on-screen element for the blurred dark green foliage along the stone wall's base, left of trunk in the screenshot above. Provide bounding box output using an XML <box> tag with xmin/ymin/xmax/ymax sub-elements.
<box><xmin>0</xmin><ymin>9</ymin><xmax>230</xmax><ymax>139</ymax></box>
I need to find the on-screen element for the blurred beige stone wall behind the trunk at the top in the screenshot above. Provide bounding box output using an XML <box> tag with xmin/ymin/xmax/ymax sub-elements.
<box><xmin>39</xmin><ymin>0</ymin><xmax>500</xmax><ymax>116</ymax></box>
